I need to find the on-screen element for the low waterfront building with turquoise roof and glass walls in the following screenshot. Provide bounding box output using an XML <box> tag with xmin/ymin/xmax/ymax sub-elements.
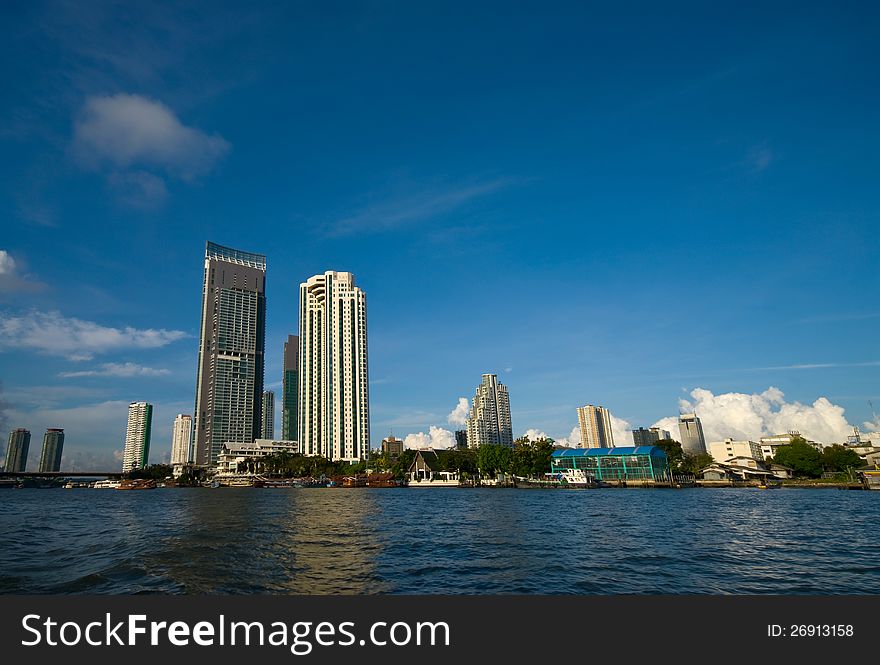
<box><xmin>550</xmin><ymin>446</ymin><xmax>672</xmax><ymax>483</ymax></box>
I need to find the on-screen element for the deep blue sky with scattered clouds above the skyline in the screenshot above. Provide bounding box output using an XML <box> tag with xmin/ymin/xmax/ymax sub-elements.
<box><xmin>0</xmin><ymin>2</ymin><xmax>880</xmax><ymax>464</ymax></box>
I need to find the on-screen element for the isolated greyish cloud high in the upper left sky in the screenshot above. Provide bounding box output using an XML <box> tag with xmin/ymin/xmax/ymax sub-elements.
<box><xmin>73</xmin><ymin>94</ymin><xmax>229</xmax><ymax>180</ymax></box>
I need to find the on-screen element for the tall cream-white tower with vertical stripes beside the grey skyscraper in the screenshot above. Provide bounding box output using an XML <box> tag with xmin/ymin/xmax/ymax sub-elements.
<box><xmin>297</xmin><ymin>270</ymin><xmax>370</xmax><ymax>461</ymax></box>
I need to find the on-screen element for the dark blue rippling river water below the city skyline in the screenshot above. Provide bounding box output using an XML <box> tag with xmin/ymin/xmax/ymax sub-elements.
<box><xmin>0</xmin><ymin>488</ymin><xmax>880</xmax><ymax>594</ymax></box>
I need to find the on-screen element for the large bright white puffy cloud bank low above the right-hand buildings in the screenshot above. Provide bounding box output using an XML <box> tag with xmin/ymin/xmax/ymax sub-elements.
<box><xmin>654</xmin><ymin>387</ymin><xmax>852</xmax><ymax>443</ymax></box>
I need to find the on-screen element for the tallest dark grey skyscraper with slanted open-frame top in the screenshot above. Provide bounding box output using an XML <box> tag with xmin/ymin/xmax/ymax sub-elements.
<box><xmin>193</xmin><ymin>242</ymin><xmax>266</xmax><ymax>465</ymax></box>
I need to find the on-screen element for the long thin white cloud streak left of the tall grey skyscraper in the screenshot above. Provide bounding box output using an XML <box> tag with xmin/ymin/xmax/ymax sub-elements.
<box><xmin>0</xmin><ymin>310</ymin><xmax>187</xmax><ymax>360</ymax></box>
